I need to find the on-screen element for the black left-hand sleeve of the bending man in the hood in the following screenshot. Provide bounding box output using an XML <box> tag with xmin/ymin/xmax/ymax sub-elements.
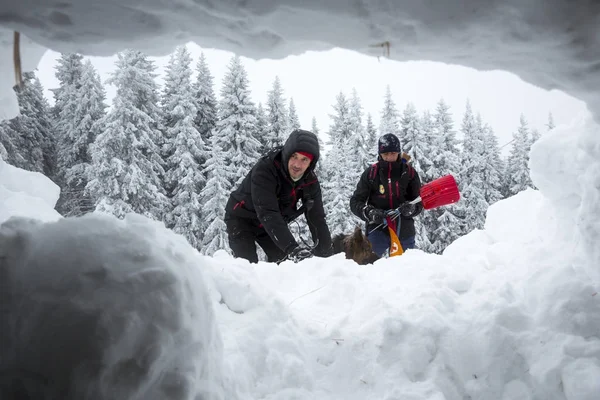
<box><xmin>250</xmin><ymin>162</ymin><xmax>298</xmax><ymax>254</ymax></box>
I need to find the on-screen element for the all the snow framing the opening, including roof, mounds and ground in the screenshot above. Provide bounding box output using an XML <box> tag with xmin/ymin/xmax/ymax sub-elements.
<box><xmin>0</xmin><ymin>0</ymin><xmax>600</xmax><ymax>400</ymax></box>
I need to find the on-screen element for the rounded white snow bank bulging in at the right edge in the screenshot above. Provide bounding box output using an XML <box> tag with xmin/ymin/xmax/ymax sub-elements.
<box><xmin>530</xmin><ymin>116</ymin><xmax>600</xmax><ymax>283</ymax></box>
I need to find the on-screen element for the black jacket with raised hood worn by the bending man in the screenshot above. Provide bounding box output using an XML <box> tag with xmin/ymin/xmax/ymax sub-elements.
<box><xmin>225</xmin><ymin>130</ymin><xmax>331</xmax><ymax>256</ymax></box>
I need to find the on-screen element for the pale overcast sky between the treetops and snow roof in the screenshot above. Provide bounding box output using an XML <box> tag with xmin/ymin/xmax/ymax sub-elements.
<box><xmin>38</xmin><ymin>44</ymin><xmax>587</xmax><ymax>153</ymax></box>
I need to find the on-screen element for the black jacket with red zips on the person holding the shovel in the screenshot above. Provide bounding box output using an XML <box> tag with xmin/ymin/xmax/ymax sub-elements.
<box><xmin>350</xmin><ymin>157</ymin><xmax>421</xmax><ymax>239</ymax></box>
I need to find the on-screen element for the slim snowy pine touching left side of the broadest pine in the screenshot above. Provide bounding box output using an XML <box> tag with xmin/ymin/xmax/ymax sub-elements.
<box><xmin>56</xmin><ymin>60</ymin><xmax>106</xmax><ymax>216</ymax></box>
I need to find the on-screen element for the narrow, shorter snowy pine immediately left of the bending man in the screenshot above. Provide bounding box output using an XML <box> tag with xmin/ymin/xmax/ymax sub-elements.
<box><xmin>200</xmin><ymin>134</ymin><xmax>234</xmax><ymax>256</ymax></box>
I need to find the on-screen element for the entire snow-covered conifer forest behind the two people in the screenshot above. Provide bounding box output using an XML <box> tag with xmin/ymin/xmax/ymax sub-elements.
<box><xmin>0</xmin><ymin>46</ymin><xmax>554</xmax><ymax>255</ymax></box>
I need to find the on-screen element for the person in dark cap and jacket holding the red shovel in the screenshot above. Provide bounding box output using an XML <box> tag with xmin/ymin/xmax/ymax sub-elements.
<box><xmin>350</xmin><ymin>133</ymin><xmax>423</xmax><ymax>257</ymax></box>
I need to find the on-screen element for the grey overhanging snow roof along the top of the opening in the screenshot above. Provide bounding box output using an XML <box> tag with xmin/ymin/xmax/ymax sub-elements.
<box><xmin>1</xmin><ymin>0</ymin><xmax>600</xmax><ymax>117</ymax></box>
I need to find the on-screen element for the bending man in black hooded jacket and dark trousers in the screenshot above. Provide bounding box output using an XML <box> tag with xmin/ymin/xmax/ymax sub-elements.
<box><xmin>225</xmin><ymin>129</ymin><xmax>332</xmax><ymax>263</ymax></box>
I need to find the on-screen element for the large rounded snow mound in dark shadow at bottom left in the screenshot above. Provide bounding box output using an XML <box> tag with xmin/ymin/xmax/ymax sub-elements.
<box><xmin>0</xmin><ymin>214</ymin><xmax>234</xmax><ymax>400</ymax></box>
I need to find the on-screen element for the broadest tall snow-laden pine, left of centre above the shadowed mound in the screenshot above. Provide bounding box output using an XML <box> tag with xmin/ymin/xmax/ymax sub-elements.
<box><xmin>86</xmin><ymin>50</ymin><xmax>168</xmax><ymax>220</ymax></box>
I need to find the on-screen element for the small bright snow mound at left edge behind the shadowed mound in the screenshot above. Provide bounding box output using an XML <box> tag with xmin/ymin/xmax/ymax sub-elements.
<box><xmin>0</xmin><ymin>157</ymin><xmax>61</xmax><ymax>224</ymax></box>
